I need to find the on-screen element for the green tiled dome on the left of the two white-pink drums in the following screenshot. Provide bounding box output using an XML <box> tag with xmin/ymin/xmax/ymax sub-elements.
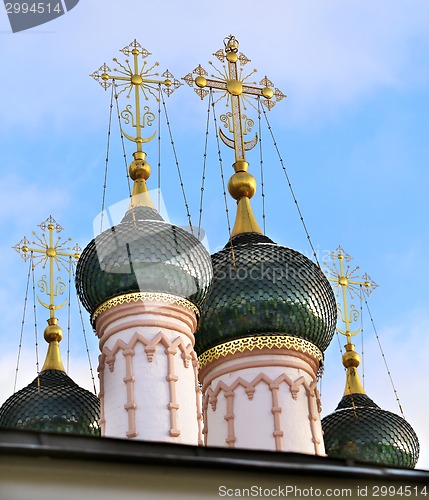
<box><xmin>76</xmin><ymin>207</ymin><xmax>212</xmax><ymax>314</ymax></box>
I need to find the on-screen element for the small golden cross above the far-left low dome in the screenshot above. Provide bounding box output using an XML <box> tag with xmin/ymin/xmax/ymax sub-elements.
<box><xmin>12</xmin><ymin>215</ymin><xmax>80</xmax><ymax>319</ymax></box>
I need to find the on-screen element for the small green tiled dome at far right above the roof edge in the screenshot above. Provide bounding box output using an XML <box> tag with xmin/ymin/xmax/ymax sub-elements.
<box><xmin>322</xmin><ymin>394</ymin><xmax>420</xmax><ymax>469</ymax></box>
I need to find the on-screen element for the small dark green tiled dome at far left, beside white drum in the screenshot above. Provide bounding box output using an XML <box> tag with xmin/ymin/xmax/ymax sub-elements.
<box><xmin>0</xmin><ymin>370</ymin><xmax>100</xmax><ymax>436</ymax></box>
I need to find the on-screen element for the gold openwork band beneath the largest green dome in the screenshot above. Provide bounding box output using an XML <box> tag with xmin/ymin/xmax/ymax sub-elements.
<box><xmin>198</xmin><ymin>335</ymin><xmax>323</xmax><ymax>368</ymax></box>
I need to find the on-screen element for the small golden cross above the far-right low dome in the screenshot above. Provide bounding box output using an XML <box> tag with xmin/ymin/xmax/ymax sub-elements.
<box><xmin>324</xmin><ymin>246</ymin><xmax>378</xmax><ymax>344</ymax></box>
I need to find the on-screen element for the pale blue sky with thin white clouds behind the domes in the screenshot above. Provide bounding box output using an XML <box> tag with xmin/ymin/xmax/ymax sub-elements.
<box><xmin>0</xmin><ymin>0</ymin><xmax>429</xmax><ymax>469</ymax></box>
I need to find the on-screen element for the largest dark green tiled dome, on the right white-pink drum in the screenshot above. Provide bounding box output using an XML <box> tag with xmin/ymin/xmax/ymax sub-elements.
<box><xmin>195</xmin><ymin>233</ymin><xmax>337</xmax><ymax>355</ymax></box>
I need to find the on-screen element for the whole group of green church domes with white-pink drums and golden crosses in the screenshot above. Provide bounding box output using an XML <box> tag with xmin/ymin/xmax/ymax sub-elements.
<box><xmin>0</xmin><ymin>35</ymin><xmax>419</xmax><ymax>468</ymax></box>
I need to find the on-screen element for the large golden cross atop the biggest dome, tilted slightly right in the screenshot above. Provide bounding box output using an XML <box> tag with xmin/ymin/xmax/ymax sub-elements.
<box><xmin>183</xmin><ymin>35</ymin><xmax>286</xmax><ymax>163</ymax></box>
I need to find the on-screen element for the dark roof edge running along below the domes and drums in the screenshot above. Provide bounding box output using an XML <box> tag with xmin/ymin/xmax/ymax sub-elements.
<box><xmin>0</xmin><ymin>429</ymin><xmax>429</xmax><ymax>484</ymax></box>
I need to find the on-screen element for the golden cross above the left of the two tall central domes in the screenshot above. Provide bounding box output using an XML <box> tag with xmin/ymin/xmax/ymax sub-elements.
<box><xmin>90</xmin><ymin>39</ymin><xmax>182</xmax><ymax>152</ymax></box>
